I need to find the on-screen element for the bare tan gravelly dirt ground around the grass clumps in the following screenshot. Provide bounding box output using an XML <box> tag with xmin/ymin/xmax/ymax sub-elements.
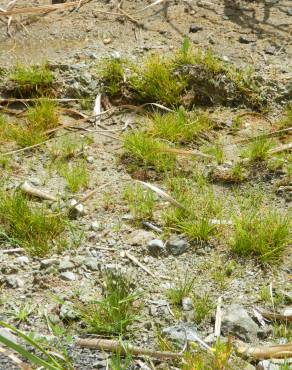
<box><xmin>0</xmin><ymin>0</ymin><xmax>292</xmax><ymax>370</ymax></box>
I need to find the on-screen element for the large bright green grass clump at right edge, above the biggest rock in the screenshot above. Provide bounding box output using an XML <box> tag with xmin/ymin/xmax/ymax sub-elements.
<box><xmin>230</xmin><ymin>205</ymin><xmax>290</xmax><ymax>263</ymax></box>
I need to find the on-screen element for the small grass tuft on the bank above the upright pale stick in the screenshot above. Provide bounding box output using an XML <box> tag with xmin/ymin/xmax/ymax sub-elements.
<box><xmin>99</xmin><ymin>58</ymin><xmax>128</xmax><ymax>96</ymax></box>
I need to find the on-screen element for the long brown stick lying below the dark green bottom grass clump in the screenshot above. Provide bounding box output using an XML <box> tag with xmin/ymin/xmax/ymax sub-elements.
<box><xmin>76</xmin><ymin>338</ymin><xmax>181</xmax><ymax>360</ymax></box>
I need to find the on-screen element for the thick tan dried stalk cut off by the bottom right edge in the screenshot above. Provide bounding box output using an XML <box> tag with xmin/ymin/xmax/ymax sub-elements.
<box><xmin>236</xmin><ymin>343</ymin><xmax>292</xmax><ymax>360</ymax></box>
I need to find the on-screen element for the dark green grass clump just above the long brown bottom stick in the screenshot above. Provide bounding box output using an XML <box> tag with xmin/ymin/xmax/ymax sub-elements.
<box><xmin>77</xmin><ymin>272</ymin><xmax>138</xmax><ymax>335</ymax></box>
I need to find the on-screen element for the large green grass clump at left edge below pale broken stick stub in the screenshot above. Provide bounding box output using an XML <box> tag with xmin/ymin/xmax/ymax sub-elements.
<box><xmin>0</xmin><ymin>191</ymin><xmax>66</xmax><ymax>257</ymax></box>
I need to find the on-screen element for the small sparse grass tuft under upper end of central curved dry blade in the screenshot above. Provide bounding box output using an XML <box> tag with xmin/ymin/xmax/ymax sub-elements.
<box><xmin>124</xmin><ymin>184</ymin><xmax>156</xmax><ymax>220</ymax></box>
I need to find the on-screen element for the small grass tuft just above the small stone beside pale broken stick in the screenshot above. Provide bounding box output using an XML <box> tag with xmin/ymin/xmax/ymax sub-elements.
<box><xmin>60</xmin><ymin>160</ymin><xmax>89</xmax><ymax>193</ymax></box>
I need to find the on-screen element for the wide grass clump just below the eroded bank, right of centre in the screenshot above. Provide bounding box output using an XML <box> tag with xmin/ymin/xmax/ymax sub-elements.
<box><xmin>149</xmin><ymin>108</ymin><xmax>213</xmax><ymax>143</ymax></box>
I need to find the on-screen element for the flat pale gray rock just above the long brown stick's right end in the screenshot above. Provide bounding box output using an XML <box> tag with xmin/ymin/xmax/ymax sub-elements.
<box><xmin>162</xmin><ymin>323</ymin><xmax>198</xmax><ymax>346</ymax></box>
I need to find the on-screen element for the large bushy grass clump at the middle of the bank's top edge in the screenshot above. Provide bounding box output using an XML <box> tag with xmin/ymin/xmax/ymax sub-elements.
<box><xmin>129</xmin><ymin>55</ymin><xmax>187</xmax><ymax>106</ymax></box>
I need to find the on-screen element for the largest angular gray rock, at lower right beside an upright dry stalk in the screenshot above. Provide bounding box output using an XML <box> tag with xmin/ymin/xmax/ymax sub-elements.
<box><xmin>222</xmin><ymin>304</ymin><xmax>260</xmax><ymax>342</ymax></box>
